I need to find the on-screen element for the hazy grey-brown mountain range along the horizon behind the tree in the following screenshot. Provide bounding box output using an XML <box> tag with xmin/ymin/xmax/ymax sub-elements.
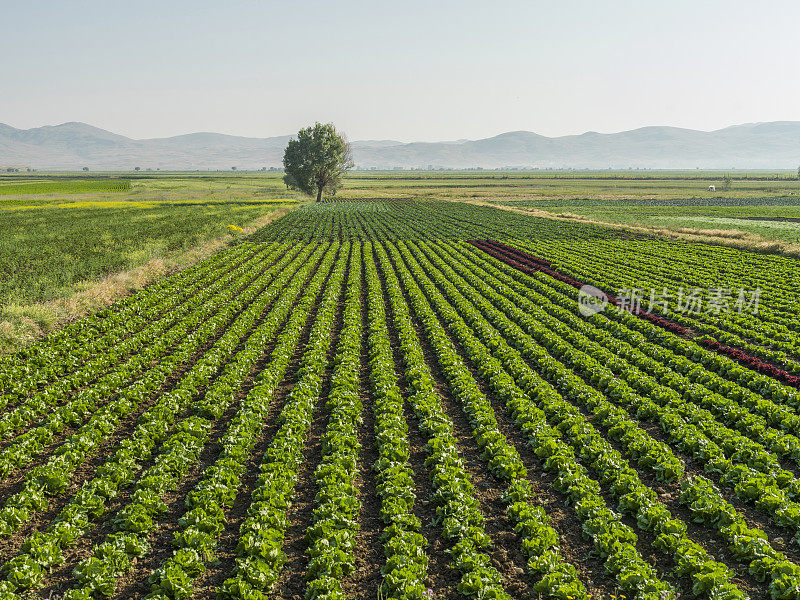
<box><xmin>0</xmin><ymin>121</ymin><xmax>800</xmax><ymax>170</ymax></box>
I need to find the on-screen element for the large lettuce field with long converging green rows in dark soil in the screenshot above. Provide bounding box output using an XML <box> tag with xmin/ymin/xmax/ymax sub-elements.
<box><xmin>0</xmin><ymin>200</ymin><xmax>800</xmax><ymax>600</ymax></box>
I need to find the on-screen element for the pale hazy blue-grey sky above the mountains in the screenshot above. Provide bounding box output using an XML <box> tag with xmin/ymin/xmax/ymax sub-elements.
<box><xmin>0</xmin><ymin>0</ymin><xmax>800</xmax><ymax>141</ymax></box>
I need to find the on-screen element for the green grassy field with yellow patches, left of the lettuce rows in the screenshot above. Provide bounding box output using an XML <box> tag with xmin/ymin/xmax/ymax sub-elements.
<box><xmin>0</xmin><ymin>177</ymin><xmax>297</xmax><ymax>349</ymax></box>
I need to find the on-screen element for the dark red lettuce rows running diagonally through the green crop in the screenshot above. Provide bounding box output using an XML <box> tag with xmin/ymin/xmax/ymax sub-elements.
<box><xmin>467</xmin><ymin>239</ymin><xmax>800</xmax><ymax>389</ymax></box>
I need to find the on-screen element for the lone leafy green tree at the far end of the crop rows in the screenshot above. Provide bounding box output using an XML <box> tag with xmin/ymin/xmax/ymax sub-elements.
<box><xmin>283</xmin><ymin>123</ymin><xmax>353</xmax><ymax>202</ymax></box>
